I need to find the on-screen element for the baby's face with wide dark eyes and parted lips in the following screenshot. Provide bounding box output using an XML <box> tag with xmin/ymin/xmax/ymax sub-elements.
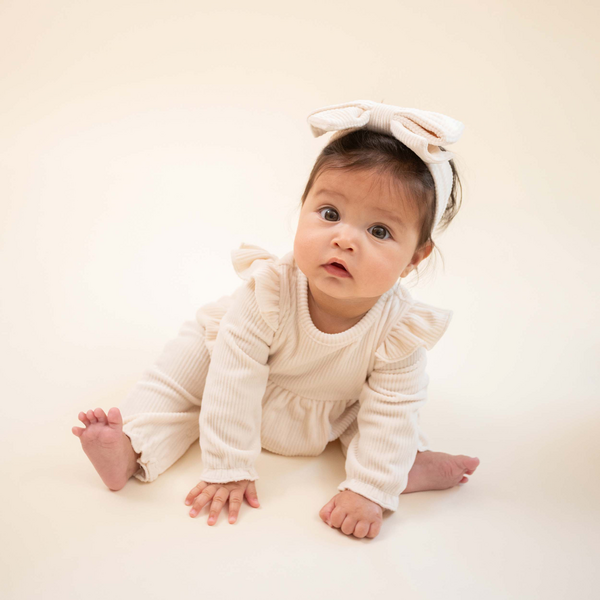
<box><xmin>294</xmin><ymin>170</ymin><xmax>431</xmax><ymax>301</ymax></box>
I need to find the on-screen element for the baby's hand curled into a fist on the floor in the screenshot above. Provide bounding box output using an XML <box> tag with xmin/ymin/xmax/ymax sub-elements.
<box><xmin>319</xmin><ymin>490</ymin><xmax>383</xmax><ymax>538</ymax></box>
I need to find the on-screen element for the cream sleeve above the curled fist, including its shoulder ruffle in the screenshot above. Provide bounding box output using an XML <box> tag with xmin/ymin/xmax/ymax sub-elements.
<box><xmin>338</xmin><ymin>301</ymin><xmax>454</xmax><ymax>511</ymax></box>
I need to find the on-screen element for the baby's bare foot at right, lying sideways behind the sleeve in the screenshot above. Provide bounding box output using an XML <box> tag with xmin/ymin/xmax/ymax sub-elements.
<box><xmin>402</xmin><ymin>450</ymin><xmax>479</xmax><ymax>494</ymax></box>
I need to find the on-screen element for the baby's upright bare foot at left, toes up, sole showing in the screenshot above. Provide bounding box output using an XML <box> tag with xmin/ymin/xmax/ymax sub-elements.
<box><xmin>71</xmin><ymin>408</ymin><xmax>140</xmax><ymax>491</ymax></box>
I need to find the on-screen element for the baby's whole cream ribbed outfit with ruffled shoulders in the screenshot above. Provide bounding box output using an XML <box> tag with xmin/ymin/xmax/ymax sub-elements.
<box><xmin>120</xmin><ymin>243</ymin><xmax>453</xmax><ymax>511</ymax></box>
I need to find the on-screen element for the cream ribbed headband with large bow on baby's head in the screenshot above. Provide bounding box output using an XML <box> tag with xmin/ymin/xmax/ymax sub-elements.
<box><xmin>308</xmin><ymin>100</ymin><xmax>465</xmax><ymax>229</ymax></box>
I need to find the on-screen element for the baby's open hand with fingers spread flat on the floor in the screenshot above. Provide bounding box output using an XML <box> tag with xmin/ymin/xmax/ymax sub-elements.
<box><xmin>185</xmin><ymin>479</ymin><xmax>260</xmax><ymax>525</ymax></box>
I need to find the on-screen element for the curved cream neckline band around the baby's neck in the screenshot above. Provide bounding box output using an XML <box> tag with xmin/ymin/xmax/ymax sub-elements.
<box><xmin>296</xmin><ymin>266</ymin><xmax>394</xmax><ymax>345</ymax></box>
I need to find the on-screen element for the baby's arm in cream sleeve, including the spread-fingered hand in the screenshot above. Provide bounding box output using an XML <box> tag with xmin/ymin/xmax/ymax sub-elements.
<box><xmin>186</xmin><ymin>280</ymin><xmax>276</xmax><ymax>525</ymax></box>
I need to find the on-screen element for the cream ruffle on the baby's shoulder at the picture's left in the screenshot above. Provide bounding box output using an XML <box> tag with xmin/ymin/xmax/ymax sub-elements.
<box><xmin>231</xmin><ymin>243</ymin><xmax>280</xmax><ymax>331</ymax></box>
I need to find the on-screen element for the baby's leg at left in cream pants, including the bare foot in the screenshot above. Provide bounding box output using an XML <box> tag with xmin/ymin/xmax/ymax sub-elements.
<box><xmin>72</xmin><ymin>321</ymin><xmax>210</xmax><ymax>490</ymax></box>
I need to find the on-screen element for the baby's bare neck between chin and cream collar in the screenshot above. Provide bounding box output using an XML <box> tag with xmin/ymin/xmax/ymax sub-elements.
<box><xmin>308</xmin><ymin>285</ymin><xmax>379</xmax><ymax>333</ymax></box>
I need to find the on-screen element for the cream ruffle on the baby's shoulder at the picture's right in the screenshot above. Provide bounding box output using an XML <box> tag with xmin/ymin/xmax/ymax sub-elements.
<box><xmin>375</xmin><ymin>300</ymin><xmax>454</xmax><ymax>363</ymax></box>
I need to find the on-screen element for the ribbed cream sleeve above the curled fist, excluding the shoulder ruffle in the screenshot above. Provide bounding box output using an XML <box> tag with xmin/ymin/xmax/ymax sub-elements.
<box><xmin>338</xmin><ymin>347</ymin><xmax>429</xmax><ymax>511</ymax></box>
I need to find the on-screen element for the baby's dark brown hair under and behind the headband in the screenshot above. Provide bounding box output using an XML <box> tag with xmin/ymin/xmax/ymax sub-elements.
<box><xmin>301</xmin><ymin>128</ymin><xmax>462</xmax><ymax>277</ymax></box>
